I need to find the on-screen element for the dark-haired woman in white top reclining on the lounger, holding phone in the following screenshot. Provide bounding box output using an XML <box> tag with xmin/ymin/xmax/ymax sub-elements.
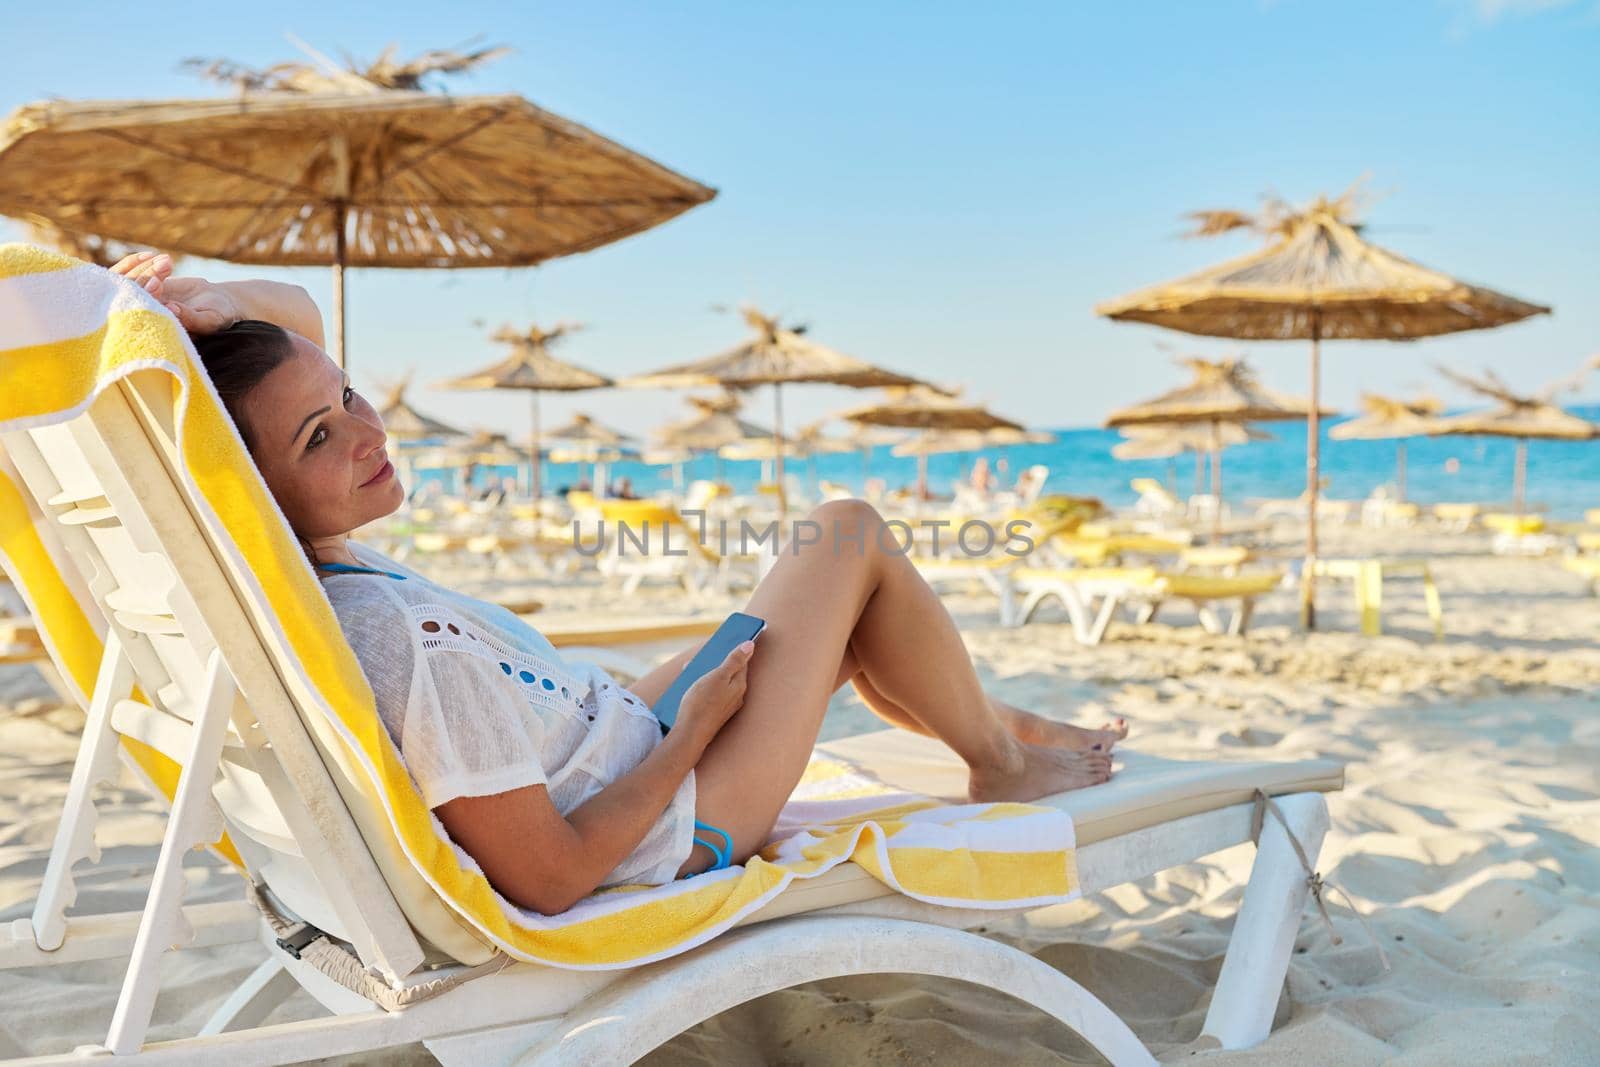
<box><xmin>114</xmin><ymin>254</ymin><xmax>1126</xmax><ymax>913</ymax></box>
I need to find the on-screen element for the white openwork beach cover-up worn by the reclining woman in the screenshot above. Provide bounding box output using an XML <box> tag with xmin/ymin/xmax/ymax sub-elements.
<box><xmin>323</xmin><ymin>544</ymin><xmax>694</xmax><ymax>886</ymax></box>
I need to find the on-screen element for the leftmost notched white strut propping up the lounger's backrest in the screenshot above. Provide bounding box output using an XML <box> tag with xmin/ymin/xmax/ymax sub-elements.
<box><xmin>32</xmin><ymin>627</ymin><xmax>133</xmax><ymax>952</ymax></box>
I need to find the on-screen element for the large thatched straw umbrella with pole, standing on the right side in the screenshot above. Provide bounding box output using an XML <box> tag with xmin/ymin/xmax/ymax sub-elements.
<box><xmin>1094</xmin><ymin>186</ymin><xmax>1550</xmax><ymax>629</ymax></box>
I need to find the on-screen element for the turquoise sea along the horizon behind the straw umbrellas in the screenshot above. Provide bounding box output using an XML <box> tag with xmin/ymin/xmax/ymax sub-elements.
<box><xmin>419</xmin><ymin>405</ymin><xmax>1600</xmax><ymax>518</ymax></box>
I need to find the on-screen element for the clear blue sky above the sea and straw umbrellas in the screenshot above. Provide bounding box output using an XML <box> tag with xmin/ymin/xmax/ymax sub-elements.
<box><xmin>0</xmin><ymin>0</ymin><xmax>1600</xmax><ymax>430</ymax></box>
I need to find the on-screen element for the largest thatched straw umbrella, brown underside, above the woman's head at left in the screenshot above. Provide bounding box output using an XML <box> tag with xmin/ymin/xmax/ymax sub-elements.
<box><xmin>0</xmin><ymin>41</ymin><xmax>715</xmax><ymax>362</ymax></box>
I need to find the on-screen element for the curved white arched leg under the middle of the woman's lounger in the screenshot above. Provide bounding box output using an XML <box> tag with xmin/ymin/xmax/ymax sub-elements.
<box><xmin>505</xmin><ymin>917</ymin><xmax>1155</xmax><ymax>1067</ymax></box>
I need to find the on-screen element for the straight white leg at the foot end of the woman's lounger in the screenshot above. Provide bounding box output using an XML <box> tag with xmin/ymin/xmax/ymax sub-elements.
<box><xmin>1202</xmin><ymin>793</ymin><xmax>1328</xmax><ymax>1049</ymax></box>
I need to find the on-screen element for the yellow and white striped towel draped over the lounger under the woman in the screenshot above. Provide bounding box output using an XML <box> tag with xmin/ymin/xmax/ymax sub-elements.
<box><xmin>0</xmin><ymin>245</ymin><xmax>1078</xmax><ymax>969</ymax></box>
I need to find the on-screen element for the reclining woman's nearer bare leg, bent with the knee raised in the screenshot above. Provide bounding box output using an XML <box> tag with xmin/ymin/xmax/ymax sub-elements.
<box><xmin>694</xmin><ymin>501</ymin><xmax>1110</xmax><ymax>865</ymax></box>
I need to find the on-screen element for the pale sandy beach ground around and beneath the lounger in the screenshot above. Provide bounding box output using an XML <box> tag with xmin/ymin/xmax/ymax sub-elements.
<box><xmin>0</xmin><ymin>528</ymin><xmax>1600</xmax><ymax>1065</ymax></box>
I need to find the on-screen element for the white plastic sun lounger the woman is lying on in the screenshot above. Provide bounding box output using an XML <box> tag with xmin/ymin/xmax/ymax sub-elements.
<box><xmin>0</xmin><ymin>371</ymin><xmax>1342</xmax><ymax>1067</ymax></box>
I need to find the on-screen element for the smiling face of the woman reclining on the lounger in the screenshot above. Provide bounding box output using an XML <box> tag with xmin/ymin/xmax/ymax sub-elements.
<box><xmin>240</xmin><ymin>333</ymin><xmax>405</xmax><ymax>541</ymax></box>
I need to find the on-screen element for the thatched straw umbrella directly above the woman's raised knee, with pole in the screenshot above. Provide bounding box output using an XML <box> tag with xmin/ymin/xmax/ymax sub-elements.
<box><xmin>619</xmin><ymin>307</ymin><xmax>920</xmax><ymax>510</ymax></box>
